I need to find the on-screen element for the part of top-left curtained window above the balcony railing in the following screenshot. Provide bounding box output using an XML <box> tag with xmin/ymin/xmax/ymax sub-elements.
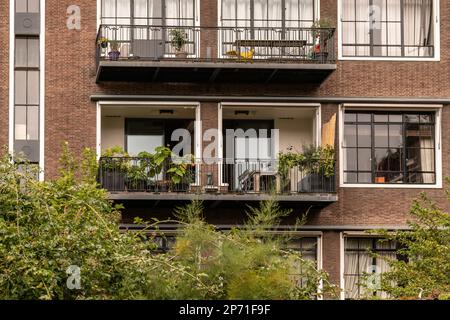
<box><xmin>101</xmin><ymin>0</ymin><xmax>196</xmax><ymax>26</ymax></box>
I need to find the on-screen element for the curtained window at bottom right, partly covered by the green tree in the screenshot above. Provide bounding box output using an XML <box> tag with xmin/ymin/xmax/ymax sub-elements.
<box><xmin>344</xmin><ymin>237</ymin><xmax>397</xmax><ymax>299</ymax></box>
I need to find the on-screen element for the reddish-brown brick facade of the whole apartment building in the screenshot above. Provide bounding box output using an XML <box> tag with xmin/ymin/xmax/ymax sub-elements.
<box><xmin>0</xmin><ymin>0</ymin><xmax>450</xmax><ymax>294</ymax></box>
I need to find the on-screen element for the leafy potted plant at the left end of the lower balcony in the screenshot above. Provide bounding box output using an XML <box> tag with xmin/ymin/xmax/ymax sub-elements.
<box><xmin>99</xmin><ymin>146</ymin><xmax>129</xmax><ymax>191</ymax></box>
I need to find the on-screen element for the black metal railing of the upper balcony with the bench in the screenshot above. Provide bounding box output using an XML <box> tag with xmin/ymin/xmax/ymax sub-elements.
<box><xmin>96</xmin><ymin>25</ymin><xmax>336</xmax><ymax>64</ymax></box>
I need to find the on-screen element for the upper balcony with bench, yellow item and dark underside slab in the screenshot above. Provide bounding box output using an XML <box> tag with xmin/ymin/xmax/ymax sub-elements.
<box><xmin>96</xmin><ymin>25</ymin><xmax>336</xmax><ymax>84</ymax></box>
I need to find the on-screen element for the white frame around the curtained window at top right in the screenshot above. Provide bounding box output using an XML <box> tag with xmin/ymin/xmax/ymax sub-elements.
<box><xmin>337</xmin><ymin>0</ymin><xmax>441</xmax><ymax>62</ymax></box>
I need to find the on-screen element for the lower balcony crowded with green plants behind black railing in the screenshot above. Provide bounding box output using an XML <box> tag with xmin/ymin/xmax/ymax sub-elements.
<box><xmin>98</xmin><ymin>157</ymin><xmax>337</xmax><ymax>203</ymax></box>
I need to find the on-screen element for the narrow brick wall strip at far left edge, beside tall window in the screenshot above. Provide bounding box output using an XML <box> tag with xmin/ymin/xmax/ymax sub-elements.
<box><xmin>0</xmin><ymin>1</ymin><xmax>9</xmax><ymax>148</ymax></box>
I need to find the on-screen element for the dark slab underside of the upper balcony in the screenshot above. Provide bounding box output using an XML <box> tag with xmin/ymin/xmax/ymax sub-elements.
<box><xmin>96</xmin><ymin>59</ymin><xmax>336</xmax><ymax>84</ymax></box>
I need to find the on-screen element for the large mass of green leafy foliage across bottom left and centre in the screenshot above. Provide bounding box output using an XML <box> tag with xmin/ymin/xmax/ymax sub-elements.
<box><xmin>0</xmin><ymin>145</ymin><xmax>338</xmax><ymax>299</ymax></box>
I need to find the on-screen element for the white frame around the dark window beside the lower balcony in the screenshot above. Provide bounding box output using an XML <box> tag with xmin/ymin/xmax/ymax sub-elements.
<box><xmin>339</xmin><ymin>103</ymin><xmax>443</xmax><ymax>189</ymax></box>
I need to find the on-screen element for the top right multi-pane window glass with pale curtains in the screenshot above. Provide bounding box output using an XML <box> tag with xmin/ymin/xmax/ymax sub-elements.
<box><xmin>341</xmin><ymin>0</ymin><xmax>435</xmax><ymax>58</ymax></box>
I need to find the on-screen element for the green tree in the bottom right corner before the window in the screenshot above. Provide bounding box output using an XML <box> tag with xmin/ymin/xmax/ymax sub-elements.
<box><xmin>368</xmin><ymin>186</ymin><xmax>450</xmax><ymax>299</ymax></box>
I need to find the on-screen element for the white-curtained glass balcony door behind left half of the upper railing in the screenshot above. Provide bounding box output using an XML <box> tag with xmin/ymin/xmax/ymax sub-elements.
<box><xmin>101</xmin><ymin>0</ymin><xmax>196</xmax><ymax>58</ymax></box>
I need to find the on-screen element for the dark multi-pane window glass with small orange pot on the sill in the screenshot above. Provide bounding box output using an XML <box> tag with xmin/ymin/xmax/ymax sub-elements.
<box><xmin>343</xmin><ymin>111</ymin><xmax>436</xmax><ymax>184</ymax></box>
